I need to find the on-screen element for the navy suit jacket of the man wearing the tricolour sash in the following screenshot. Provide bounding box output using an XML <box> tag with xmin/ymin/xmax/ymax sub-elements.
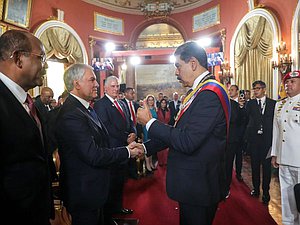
<box><xmin>145</xmin><ymin>85</ymin><xmax>226</xmax><ymax>206</ymax></box>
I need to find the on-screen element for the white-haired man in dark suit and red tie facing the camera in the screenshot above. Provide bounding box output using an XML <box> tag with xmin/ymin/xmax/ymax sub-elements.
<box><xmin>94</xmin><ymin>76</ymin><xmax>136</xmax><ymax>223</ymax></box>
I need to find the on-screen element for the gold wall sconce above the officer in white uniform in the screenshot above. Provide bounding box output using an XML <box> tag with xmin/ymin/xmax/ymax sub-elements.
<box><xmin>272</xmin><ymin>41</ymin><xmax>293</xmax><ymax>75</ymax></box>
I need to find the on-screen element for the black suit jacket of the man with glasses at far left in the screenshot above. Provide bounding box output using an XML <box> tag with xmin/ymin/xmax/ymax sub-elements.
<box><xmin>0</xmin><ymin>80</ymin><xmax>51</xmax><ymax>223</ymax></box>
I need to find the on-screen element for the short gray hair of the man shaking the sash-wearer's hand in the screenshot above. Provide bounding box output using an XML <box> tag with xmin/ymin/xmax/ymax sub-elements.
<box><xmin>64</xmin><ymin>63</ymin><xmax>94</xmax><ymax>92</ymax></box>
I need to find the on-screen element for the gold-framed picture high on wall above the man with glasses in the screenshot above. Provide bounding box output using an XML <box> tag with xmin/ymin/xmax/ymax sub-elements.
<box><xmin>3</xmin><ymin>0</ymin><xmax>32</xmax><ymax>28</ymax></box>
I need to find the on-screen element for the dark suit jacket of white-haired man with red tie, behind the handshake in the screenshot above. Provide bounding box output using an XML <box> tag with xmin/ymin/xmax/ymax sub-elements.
<box><xmin>94</xmin><ymin>95</ymin><xmax>135</xmax><ymax>147</ymax></box>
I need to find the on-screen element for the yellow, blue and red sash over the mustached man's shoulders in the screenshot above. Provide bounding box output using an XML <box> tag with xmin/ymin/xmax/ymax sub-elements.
<box><xmin>174</xmin><ymin>79</ymin><xmax>231</xmax><ymax>134</ymax></box>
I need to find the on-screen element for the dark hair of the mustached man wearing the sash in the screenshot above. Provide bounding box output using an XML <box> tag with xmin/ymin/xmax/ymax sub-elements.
<box><xmin>174</xmin><ymin>41</ymin><xmax>207</xmax><ymax>69</ymax></box>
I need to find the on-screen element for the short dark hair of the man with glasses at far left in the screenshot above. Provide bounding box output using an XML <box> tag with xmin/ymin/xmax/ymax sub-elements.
<box><xmin>0</xmin><ymin>30</ymin><xmax>32</xmax><ymax>61</ymax></box>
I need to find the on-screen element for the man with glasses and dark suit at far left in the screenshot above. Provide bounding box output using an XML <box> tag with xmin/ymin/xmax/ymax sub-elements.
<box><xmin>0</xmin><ymin>30</ymin><xmax>54</xmax><ymax>225</ymax></box>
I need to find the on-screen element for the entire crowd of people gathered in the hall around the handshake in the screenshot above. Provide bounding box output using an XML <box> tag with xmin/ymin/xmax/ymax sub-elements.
<box><xmin>0</xmin><ymin>30</ymin><xmax>300</xmax><ymax>225</ymax></box>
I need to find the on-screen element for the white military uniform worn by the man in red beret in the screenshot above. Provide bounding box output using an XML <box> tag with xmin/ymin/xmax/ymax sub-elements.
<box><xmin>271</xmin><ymin>94</ymin><xmax>300</xmax><ymax>225</ymax></box>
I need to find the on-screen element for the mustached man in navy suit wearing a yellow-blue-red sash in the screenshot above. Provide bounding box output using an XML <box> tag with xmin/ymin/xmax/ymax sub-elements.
<box><xmin>137</xmin><ymin>42</ymin><xmax>230</xmax><ymax>225</ymax></box>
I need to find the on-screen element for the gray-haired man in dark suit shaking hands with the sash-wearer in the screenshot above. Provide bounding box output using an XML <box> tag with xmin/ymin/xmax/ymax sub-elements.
<box><xmin>56</xmin><ymin>64</ymin><xmax>142</xmax><ymax>225</ymax></box>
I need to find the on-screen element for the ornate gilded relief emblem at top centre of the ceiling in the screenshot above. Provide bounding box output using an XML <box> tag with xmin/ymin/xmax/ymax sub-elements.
<box><xmin>139</xmin><ymin>0</ymin><xmax>174</xmax><ymax>19</ymax></box>
